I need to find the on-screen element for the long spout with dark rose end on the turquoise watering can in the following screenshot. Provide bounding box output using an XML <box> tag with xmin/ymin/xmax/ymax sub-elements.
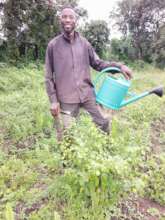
<box><xmin>120</xmin><ymin>86</ymin><xmax>163</xmax><ymax>108</ymax></box>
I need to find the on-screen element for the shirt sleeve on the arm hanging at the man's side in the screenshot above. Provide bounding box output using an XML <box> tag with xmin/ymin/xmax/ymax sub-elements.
<box><xmin>45</xmin><ymin>44</ymin><xmax>57</xmax><ymax>103</ymax></box>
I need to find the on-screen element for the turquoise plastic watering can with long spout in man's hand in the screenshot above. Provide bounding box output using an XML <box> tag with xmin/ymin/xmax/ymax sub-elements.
<box><xmin>94</xmin><ymin>67</ymin><xmax>163</xmax><ymax>110</ymax></box>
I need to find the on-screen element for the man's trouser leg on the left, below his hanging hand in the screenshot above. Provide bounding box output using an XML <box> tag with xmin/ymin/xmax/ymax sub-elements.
<box><xmin>54</xmin><ymin>103</ymin><xmax>79</xmax><ymax>141</ymax></box>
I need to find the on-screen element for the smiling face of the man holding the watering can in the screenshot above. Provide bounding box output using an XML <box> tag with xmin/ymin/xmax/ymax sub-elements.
<box><xmin>60</xmin><ymin>8</ymin><xmax>77</xmax><ymax>34</ymax></box>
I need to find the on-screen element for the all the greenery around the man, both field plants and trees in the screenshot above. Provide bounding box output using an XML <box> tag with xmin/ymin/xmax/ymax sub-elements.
<box><xmin>0</xmin><ymin>0</ymin><xmax>165</xmax><ymax>220</ymax></box>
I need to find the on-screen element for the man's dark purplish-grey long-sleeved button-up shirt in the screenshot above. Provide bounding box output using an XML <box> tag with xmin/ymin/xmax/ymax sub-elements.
<box><xmin>45</xmin><ymin>32</ymin><xmax>121</xmax><ymax>103</ymax></box>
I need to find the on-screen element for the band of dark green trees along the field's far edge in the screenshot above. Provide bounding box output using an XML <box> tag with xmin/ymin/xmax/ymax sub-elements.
<box><xmin>0</xmin><ymin>0</ymin><xmax>165</xmax><ymax>67</ymax></box>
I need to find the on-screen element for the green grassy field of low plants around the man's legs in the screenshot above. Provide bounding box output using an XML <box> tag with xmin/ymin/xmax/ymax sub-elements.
<box><xmin>0</xmin><ymin>64</ymin><xmax>165</xmax><ymax>220</ymax></box>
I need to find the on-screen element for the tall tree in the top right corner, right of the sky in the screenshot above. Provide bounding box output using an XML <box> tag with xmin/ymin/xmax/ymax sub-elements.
<box><xmin>110</xmin><ymin>0</ymin><xmax>165</xmax><ymax>61</ymax></box>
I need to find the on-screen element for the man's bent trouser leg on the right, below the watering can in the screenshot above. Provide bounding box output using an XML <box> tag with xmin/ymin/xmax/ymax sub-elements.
<box><xmin>82</xmin><ymin>99</ymin><xmax>109</xmax><ymax>133</ymax></box>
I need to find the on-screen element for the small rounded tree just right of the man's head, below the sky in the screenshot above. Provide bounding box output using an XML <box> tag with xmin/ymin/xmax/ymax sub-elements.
<box><xmin>83</xmin><ymin>20</ymin><xmax>109</xmax><ymax>56</ymax></box>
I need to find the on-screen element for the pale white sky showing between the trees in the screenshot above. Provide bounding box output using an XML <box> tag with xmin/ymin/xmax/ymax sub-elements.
<box><xmin>79</xmin><ymin>0</ymin><xmax>121</xmax><ymax>38</ymax></box>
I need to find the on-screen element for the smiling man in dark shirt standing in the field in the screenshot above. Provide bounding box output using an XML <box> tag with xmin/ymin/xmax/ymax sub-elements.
<box><xmin>45</xmin><ymin>7</ymin><xmax>132</xmax><ymax>140</ymax></box>
